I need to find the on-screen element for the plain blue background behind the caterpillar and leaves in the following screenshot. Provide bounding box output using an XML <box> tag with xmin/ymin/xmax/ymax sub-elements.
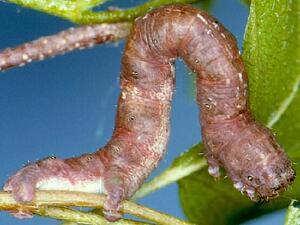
<box><xmin>0</xmin><ymin>0</ymin><xmax>284</xmax><ymax>225</ymax></box>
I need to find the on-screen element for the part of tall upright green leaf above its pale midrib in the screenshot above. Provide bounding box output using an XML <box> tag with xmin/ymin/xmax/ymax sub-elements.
<box><xmin>244</xmin><ymin>0</ymin><xmax>300</xmax><ymax>127</ymax></box>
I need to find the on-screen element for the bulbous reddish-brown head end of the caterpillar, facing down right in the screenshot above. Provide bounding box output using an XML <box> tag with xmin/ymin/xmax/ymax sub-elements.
<box><xmin>224</xmin><ymin>123</ymin><xmax>295</xmax><ymax>201</ymax></box>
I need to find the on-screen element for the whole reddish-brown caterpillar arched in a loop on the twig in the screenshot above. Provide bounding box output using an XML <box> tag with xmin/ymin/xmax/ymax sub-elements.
<box><xmin>4</xmin><ymin>5</ymin><xmax>295</xmax><ymax>221</ymax></box>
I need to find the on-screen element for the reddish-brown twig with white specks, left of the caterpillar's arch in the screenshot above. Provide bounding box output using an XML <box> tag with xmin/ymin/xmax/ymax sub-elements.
<box><xmin>0</xmin><ymin>23</ymin><xmax>130</xmax><ymax>71</ymax></box>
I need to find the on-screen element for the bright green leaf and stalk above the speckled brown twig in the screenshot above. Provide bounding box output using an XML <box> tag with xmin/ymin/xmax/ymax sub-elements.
<box><xmin>8</xmin><ymin>0</ymin><xmax>198</xmax><ymax>24</ymax></box>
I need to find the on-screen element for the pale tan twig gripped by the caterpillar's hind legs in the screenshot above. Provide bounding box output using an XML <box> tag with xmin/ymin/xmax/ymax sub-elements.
<box><xmin>0</xmin><ymin>191</ymin><xmax>195</xmax><ymax>225</ymax></box>
